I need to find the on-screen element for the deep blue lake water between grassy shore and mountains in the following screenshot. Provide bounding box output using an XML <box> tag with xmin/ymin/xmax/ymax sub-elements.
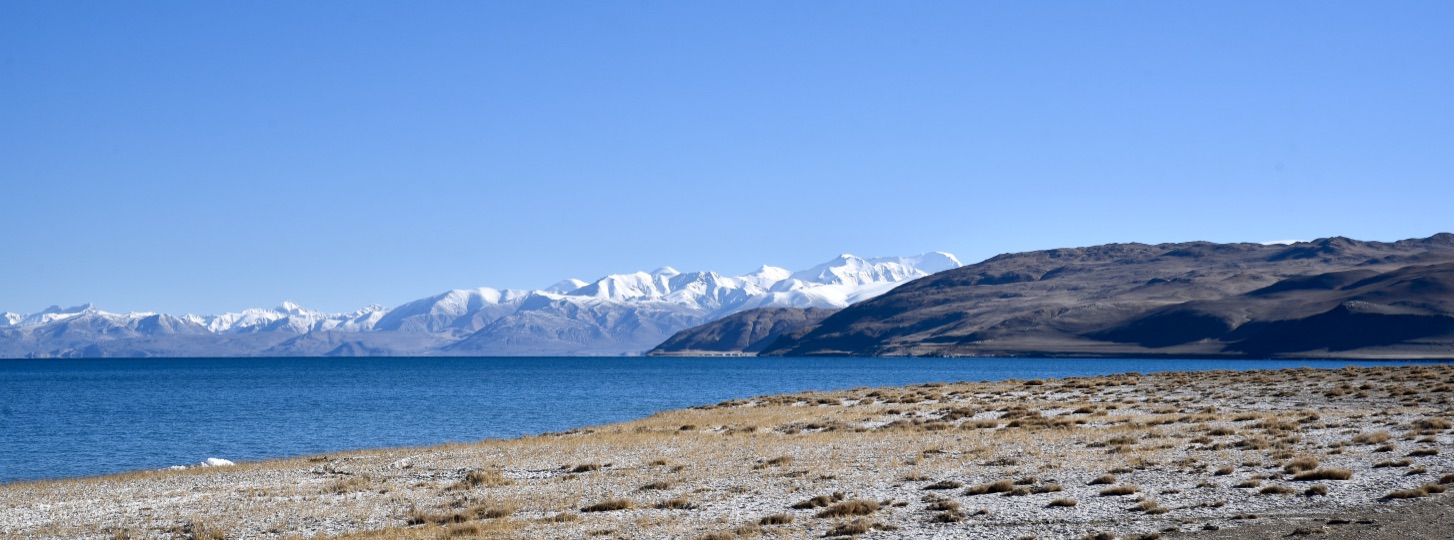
<box><xmin>0</xmin><ymin>358</ymin><xmax>1448</xmax><ymax>482</ymax></box>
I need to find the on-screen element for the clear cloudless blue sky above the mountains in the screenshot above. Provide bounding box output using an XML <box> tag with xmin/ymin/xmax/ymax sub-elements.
<box><xmin>0</xmin><ymin>0</ymin><xmax>1454</xmax><ymax>313</ymax></box>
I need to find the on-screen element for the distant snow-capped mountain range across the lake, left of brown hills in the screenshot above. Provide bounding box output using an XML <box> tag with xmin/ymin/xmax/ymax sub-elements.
<box><xmin>0</xmin><ymin>252</ymin><xmax>961</xmax><ymax>358</ymax></box>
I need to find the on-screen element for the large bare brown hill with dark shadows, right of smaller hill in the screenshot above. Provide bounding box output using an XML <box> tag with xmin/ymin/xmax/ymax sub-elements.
<box><xmin>762</xmin><ymin>233</ymin><xmax>1454</xmax><ymax>358</ymax></box>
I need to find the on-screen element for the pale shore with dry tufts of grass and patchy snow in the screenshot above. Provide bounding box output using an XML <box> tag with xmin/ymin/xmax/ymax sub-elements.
<box><xmin>0</xmin><ymin>365</ymin><xmax>1454</xmax><ymax>539</ymax></box>
